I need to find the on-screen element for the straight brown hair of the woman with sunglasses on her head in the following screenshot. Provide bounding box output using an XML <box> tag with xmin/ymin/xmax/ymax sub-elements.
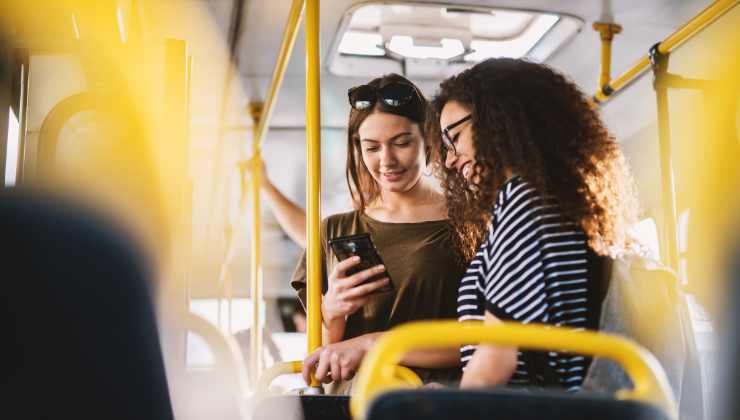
<box><xmin>345</xmin><ymin>73</ymin><xmax>439</xmax><ymax>211</ymax></box>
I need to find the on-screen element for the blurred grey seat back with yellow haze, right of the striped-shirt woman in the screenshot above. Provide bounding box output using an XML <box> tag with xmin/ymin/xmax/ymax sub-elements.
<box><xmin>584</xmin><ymin>256</ymin><xmax>704</xmax><ymax>419</ymax></box>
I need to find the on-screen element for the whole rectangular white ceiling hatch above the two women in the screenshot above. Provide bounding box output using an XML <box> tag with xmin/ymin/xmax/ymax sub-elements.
<box><xmin>328</xmin><ymin>0</ymin><xmax>583</xmax><ymax>79</ymax></box>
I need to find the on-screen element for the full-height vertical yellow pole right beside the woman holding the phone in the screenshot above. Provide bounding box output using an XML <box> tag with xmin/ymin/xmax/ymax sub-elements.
<box><xmin>306</xmin><ymin>0</ymin><xmax>322</xmax><ymax>386</ymax></box>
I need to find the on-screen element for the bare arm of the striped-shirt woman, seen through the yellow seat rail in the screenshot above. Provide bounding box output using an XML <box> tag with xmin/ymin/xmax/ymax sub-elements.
<box><xmin>460</xmin><ymin>311</ymin><xmax>517</xmax><ymax>388</ymax></box>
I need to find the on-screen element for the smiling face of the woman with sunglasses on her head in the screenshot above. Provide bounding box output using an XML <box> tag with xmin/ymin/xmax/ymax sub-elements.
<box><xmin>357</xmin><ymin>112</ymin><xmax>426</xmax><ymax>192</ymax></box>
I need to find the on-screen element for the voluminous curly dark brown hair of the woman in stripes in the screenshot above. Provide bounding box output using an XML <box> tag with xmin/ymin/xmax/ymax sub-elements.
<box><xmin>433</xmin><ymin>58</ymin><xmax>638</xmax><ymax>261</ymax></box>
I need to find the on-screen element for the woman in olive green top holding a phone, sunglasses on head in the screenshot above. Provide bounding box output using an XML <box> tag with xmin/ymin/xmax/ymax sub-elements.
<box><xmin>292</xmin><ymin>74</ymin><xmax>464</xmax><ymax>392</ymax></box>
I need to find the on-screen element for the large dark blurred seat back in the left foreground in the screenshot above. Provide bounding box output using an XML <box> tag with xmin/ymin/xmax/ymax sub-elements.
<box><xmin>0</xmin><ymin>190</ymin><xmax>173</xmax><ymax>420</ymax></box>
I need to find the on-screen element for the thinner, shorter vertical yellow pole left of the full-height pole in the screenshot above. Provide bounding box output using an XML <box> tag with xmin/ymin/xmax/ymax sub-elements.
<box><xmin>249</xmin><ymin>102</ymin><xmax>262</xmax><ymax>386</ymax></box>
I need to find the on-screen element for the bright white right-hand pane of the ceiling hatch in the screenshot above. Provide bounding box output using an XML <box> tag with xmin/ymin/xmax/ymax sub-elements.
<box><xmin>465</xmin><ymin>15</ymin><xmax>559</xmax><ymax>61</ymax></box>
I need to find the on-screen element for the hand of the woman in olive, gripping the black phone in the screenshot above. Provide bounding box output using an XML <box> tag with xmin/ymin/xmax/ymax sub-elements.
<box><xmin>321</xmin><ymin>256</ymin><xmax>390</xmax><ymax>324</ymax></box>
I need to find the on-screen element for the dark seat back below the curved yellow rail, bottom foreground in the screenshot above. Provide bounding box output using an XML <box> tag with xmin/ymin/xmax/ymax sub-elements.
<box><xmin>366</xmin><ymin>388</ymin><xmax>669</xmax><ymax>420</ymax></box>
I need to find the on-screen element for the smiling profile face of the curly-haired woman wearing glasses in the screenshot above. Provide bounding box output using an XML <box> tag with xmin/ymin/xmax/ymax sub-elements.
<box><xmin>439</xmin><ymin>101</ymin><xmax>476</xmax><ymax>183</ymax></box>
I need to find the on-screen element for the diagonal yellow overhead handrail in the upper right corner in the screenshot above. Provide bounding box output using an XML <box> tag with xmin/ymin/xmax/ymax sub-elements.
<box><xmin>594</xmin><ymin>0</ymin><xmax>740</xmax><ymax>103</ymax></box>
